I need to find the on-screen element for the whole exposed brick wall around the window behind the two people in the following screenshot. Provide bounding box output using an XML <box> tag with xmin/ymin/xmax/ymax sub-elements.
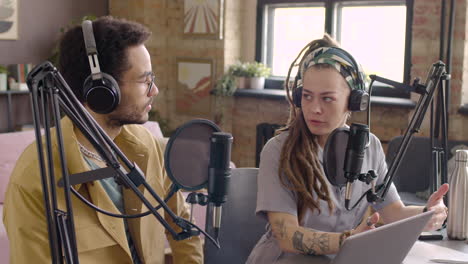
<box><xmin>109</xmin><ymin>0</ymin><xmax>468</xmax><ymax>167</ymax></box>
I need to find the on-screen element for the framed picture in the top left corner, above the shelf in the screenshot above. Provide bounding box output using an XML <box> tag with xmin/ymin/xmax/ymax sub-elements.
<box><xmin>0</xmin><ymin>0</ymin><xmax>18</xmax><ymax>40</ymax></box>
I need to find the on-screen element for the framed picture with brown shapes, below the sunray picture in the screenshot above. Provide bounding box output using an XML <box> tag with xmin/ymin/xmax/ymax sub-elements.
<box><xmin>176</xmin><ymin>58</ymin><xmax>214</xmax><ymax>116</ymax></box>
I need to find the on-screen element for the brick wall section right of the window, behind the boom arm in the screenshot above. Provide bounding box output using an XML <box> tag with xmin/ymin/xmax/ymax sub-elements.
<box><xmin>411</xmin><ymin>0</ymin><xmax>468</xmax><ymax>140</ymax></box>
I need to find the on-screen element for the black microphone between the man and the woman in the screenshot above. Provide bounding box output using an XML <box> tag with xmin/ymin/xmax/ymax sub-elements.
<box><xmin>208</xmin><ymin>132</ymin><xmax>233</xmax><ymax>237</ymax></box>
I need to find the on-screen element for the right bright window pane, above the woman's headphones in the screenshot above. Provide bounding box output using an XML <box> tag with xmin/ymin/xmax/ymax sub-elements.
<box><xmin>338</xmin><ymin>5</ymin><xmax>406</xmax><ymax>82</ymax></box>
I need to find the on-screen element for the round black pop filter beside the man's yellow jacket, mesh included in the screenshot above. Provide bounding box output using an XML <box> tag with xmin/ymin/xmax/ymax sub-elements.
<box><xmin>164</xmin><ymin>119</ymin><xmax>221</xmax><ymax>191</ymax></box>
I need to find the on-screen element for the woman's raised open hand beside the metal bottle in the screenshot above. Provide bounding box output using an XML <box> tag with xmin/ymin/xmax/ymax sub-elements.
<box><xmin>424</xmin><ymin>183</ymin><xmax>449</xmax><ymax>231</ymax></box>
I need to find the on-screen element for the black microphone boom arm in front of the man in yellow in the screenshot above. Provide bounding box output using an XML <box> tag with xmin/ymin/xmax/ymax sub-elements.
<box><xmin>27</xmin><ymin>61</ymin><xmax>210</xmax><ymax>263</ymax></box>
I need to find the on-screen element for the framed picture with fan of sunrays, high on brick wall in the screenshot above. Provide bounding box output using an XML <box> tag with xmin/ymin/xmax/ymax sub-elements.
<box><xmin>184</xmin><ymin>0</ymin><xmax>224</xmax><ymax>38</ymax></box>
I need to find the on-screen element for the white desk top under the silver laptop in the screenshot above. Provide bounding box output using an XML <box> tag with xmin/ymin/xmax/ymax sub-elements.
<box><xmin>277</xmin><ymin>237</ymin><xmax>468</xmax><ymax>264</ymax></box>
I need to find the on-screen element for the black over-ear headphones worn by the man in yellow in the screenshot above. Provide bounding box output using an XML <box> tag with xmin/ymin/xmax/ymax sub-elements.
<box><xmin>82</xmin><ymin>20</ymin><xmax>120</xmax><ymax>114</ymax></box>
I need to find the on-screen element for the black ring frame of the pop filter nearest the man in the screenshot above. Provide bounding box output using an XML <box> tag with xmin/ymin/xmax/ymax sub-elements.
<box><xmin>164</xmin><ymin>119</ymin><xmax>221</xmax><ymax>192</ymax></box>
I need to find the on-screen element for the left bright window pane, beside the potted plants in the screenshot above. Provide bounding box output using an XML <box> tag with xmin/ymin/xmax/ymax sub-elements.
<box><xmin>266</xmin><ymin>7</ymin><xmax>325</xmax><ymax>76</ymax></box>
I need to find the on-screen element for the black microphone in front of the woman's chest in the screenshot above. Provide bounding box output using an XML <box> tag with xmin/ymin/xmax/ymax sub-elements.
<box><xmin>343</xmin><ymin>123</ymin><xmax>369</xmax><ymax>210</ymax></box>
